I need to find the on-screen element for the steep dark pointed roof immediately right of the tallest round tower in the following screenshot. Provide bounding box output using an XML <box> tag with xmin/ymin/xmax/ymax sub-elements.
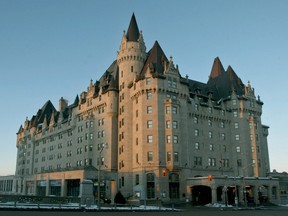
<box><xmin>140</xmin><ymin>41</ymin><xmax>168</xmax><ymax>77</ymax></box>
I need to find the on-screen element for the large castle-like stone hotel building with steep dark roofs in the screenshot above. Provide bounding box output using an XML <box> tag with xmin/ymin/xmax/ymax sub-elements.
<box><xmin>11</xmin><ymin>15</ymin><xmax>280</xmax><ymax>204</ymax></box>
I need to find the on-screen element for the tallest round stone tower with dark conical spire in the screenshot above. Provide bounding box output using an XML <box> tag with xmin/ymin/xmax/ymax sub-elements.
<box><xmin>117</xmin><ymin>14</ymin><xmax>146</xmax><ymax>195</ymax></box>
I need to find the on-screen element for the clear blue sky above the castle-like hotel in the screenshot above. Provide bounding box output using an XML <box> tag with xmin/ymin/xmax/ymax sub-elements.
<box><xmin>0</xmin><ymin>0</ymin><xmax>288</xmax><ymax>175</ymax></box>
